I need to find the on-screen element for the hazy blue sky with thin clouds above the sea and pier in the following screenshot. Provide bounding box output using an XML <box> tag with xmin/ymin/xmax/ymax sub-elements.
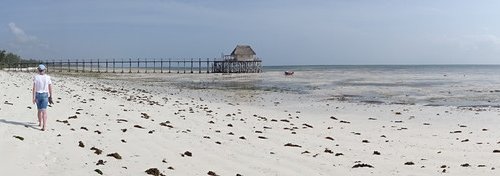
<box><xmin>0</xmin><ymin>0</ymin><xmax>500</xmax><ymax>65</ymax></box>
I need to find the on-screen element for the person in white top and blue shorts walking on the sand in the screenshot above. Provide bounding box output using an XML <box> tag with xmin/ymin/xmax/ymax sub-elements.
<box><xmin>33</xmin><ymin>64</ymin><xmax>54</xmax><ymax>131</ymax></box>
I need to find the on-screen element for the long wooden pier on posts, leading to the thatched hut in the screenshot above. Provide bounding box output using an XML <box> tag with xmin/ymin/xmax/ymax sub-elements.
<box><xmin>0</xmin><ymin>58</ymin><xmax>262</xmax><ymax>74</ymax></box>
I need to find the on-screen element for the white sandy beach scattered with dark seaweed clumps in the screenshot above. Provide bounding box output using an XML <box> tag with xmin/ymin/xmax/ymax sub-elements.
<box><xmin>0</xmin><ymin>71</ymin><xmax>500</xmax><ymax>176</ymax></box>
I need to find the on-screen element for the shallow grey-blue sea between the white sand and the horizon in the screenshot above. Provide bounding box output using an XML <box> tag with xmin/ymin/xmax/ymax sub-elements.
<box><xmin>118</xmin><ymin>65</ymin><xmax>500</xmax><ymax>107</ymax></box>
